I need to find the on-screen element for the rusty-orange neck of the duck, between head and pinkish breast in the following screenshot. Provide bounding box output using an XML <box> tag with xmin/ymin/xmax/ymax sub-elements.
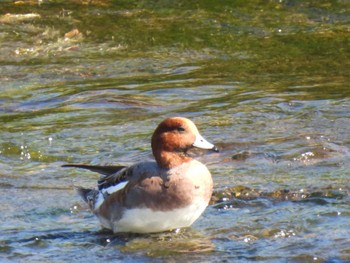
<box><xmin>154</xmin><ymin>151</ymin><xmax>192</xmax><ymax>169</ymax></box>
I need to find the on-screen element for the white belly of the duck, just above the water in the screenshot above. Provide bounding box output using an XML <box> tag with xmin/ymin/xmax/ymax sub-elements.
<box><xmin>106</xmin><ymin>200</ymin><xmax>208</xmax><ymax>233</ymax></box>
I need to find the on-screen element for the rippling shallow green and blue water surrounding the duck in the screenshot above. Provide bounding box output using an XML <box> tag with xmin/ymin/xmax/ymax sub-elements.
<box><xmin>0</xmin><ymin>1</ymin><xmax>350</xmax><ymax>262</ymax></box>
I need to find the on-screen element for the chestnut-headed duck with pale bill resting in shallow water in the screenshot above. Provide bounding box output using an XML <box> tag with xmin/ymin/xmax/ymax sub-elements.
<box><xmin>63</xmin><ymin>117</ymin><xmax>218</xmax><ymax>234</ymax></box>
